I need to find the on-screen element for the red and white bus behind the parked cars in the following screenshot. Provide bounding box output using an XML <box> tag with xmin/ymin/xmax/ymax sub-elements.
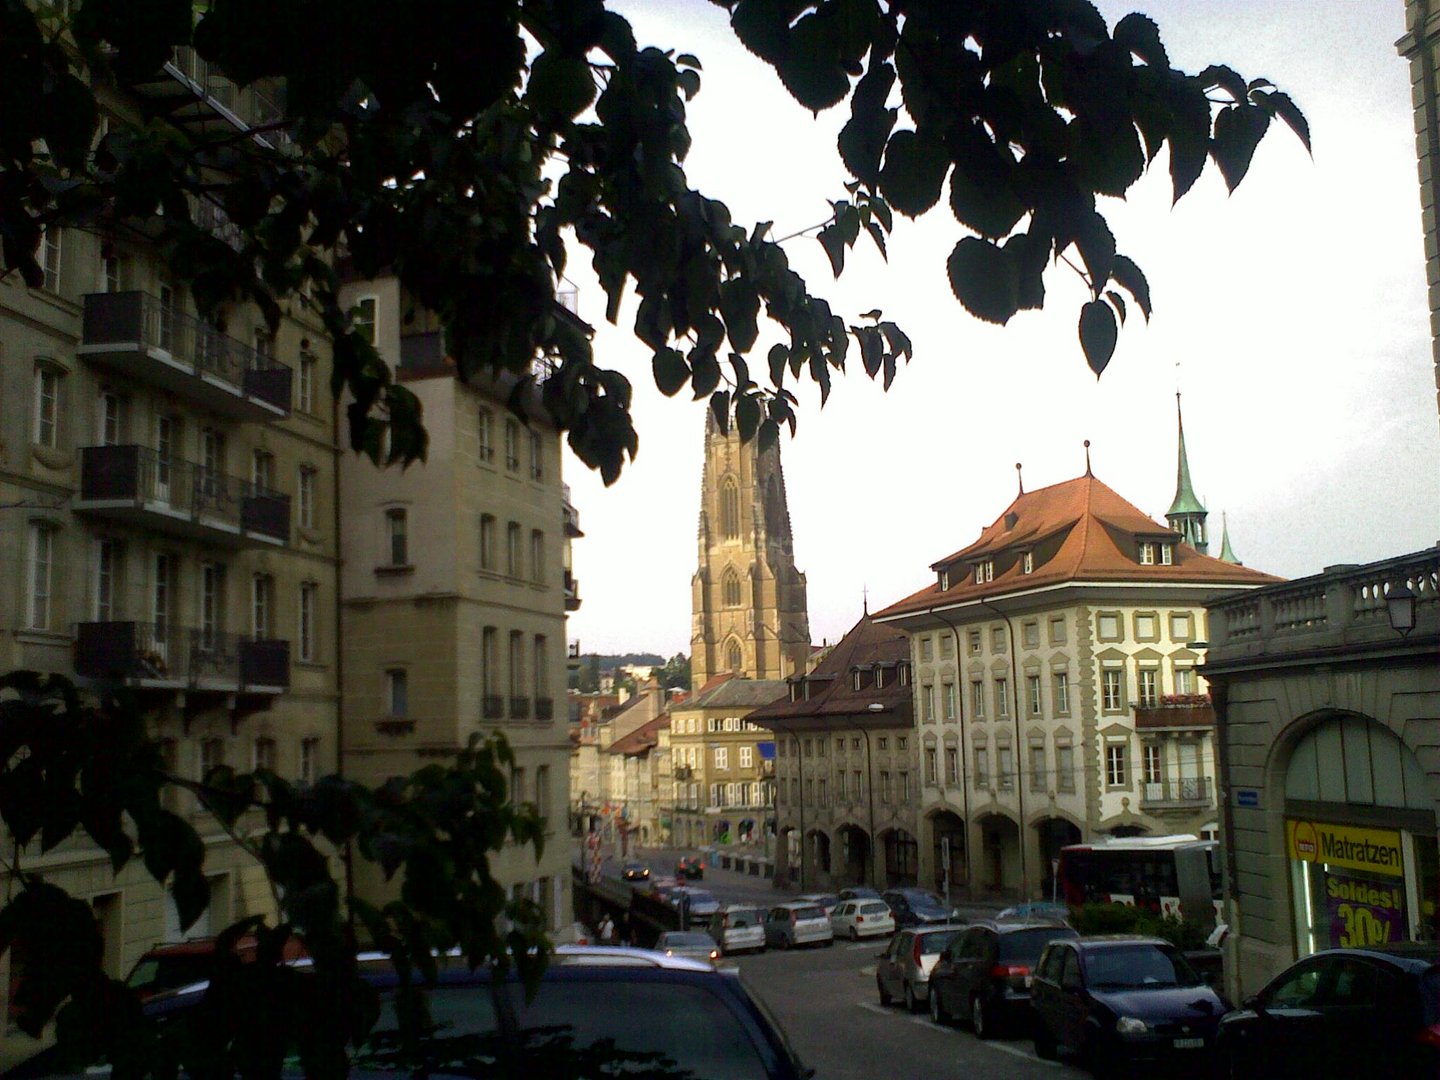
<box><xmin>1058</xmin><ymin>832</ymin><xmax>1223</xmax><ymax>924</ymax></box>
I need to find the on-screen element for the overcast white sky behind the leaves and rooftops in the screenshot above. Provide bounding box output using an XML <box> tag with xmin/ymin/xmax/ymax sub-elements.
<box><xmin>566</xmin><ymin>0</ymin><xmax>1440</xmax><ymax>655</ymax></box>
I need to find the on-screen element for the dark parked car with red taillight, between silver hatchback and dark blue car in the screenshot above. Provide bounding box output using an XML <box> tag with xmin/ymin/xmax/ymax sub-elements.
<box><xmin>930</xmin><ymin>919</ymin><xmax>1080</xmax><ymax>1038</ymax></box>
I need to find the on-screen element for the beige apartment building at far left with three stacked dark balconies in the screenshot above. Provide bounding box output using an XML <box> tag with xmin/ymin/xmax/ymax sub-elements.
<box><xmin>0</xmin><ymin>40</ymin><xmax>338</xmax><ymax>1013</ymax></box>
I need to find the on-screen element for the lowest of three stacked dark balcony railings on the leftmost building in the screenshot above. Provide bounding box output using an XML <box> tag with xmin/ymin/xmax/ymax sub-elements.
<box><xmin>75</xmin><ymin>621</ymin><xmax>289</xmax><ymax>694</ymax></box>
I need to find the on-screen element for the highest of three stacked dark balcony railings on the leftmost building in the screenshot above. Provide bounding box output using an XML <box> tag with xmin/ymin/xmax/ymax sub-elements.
<box><xmin>76</xmin><ymin>292</ymin><xmax>291</xmax><ymax>420</ymax></box>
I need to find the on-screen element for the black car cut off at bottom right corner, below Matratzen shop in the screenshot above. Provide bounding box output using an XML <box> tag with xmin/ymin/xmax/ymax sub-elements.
<box><xmin>1217</xmin><ymin>942</ymin><xmax>1440</xmax><ymax>1080</ymax></box>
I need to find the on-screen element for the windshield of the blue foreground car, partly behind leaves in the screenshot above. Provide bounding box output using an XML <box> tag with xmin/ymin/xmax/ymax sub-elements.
<box><xmin>353</xmin><ymin>979</ymin><xmax>766</xmax><ymax>1080</ymax></box>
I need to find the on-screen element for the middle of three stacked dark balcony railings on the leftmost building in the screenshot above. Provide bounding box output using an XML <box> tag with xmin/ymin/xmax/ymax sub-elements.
<box><xmin>75</xmin><ymin>445</ymin><xmax>289</xmax><ymax>546</ymax></box>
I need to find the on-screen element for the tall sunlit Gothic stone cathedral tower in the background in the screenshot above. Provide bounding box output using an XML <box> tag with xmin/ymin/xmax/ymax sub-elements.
<box><xmin>690</xmin><ymin>412</ymin><xmax>809</xmax><ymax>690</ymax></box>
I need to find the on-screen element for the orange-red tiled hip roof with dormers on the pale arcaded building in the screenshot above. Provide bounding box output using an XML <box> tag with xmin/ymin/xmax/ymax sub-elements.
<box><xmin>876</xmin><ymin>475</ymin><xmax>1282</xmax><ymax>619</ymax></box>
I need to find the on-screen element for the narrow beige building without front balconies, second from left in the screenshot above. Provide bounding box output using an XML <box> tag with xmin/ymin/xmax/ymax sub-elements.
<box><xmin>340</xmin><ymin>278</ymin><xmax>579</xmax><ymax>929</ymax></box>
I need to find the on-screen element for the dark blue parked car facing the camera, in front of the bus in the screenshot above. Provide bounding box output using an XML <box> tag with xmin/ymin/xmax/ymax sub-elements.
<box><xmin>1030</xmin><ymin>935</ymin><xmax>1226</xmax><ymax>1076</ymax></box>
